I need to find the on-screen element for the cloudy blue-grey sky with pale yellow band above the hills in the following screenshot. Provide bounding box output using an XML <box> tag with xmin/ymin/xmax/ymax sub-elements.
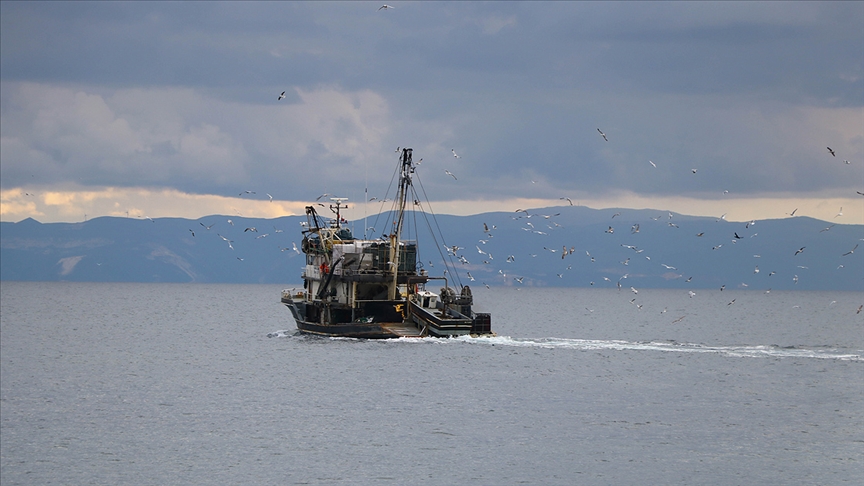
<box><xmin>0</xmin><ymin>1</ymin><xmax>864</xmax><ymax>224</ymax></box>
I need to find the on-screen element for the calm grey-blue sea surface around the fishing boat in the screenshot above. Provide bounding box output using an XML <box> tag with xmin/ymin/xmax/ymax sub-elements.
<box><xmin>0</xmin><ymin>282</ymin><xmax>864</xmax><ymax>486</ymax></box>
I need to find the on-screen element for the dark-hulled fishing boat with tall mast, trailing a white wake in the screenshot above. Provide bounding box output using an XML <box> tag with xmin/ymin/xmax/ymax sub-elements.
<box><xmin>281</xmin><ymin>148</ymin><xmax>492</xmax><ymax>339</ymax></box>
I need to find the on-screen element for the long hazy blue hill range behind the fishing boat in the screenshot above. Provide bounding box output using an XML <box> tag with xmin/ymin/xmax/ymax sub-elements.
<box><xmin>0</xmin><ymin>207</ymin><xmax>864</xmax><ymax>291</ymax></box>
